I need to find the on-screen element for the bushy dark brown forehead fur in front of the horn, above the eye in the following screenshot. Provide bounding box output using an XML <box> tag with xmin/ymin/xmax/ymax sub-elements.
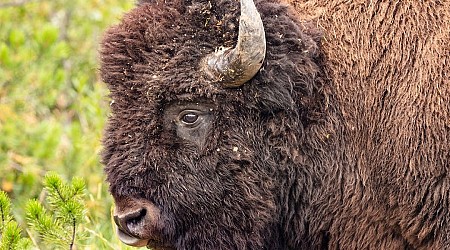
<box><xmin>101</xmin><ymin>1</ymin><xmax>239</xmax><ymax>99</ymax></box>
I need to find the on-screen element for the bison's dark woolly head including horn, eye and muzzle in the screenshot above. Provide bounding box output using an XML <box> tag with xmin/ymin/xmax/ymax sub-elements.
<box><xmin>101</xmin><ymin>0</ymin><xmax>327</xmax><ymax>249</ymax></box>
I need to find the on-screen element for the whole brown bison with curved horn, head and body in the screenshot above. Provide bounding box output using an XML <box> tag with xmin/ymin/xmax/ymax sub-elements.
<box><xmin>100</xmin><ymin>0</ymin><xmax>450</xmax><ymax>249</ymax></box>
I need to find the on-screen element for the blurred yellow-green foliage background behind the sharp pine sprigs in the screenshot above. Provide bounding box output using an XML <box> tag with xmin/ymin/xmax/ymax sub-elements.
<box><xmin>0</xmin><ymin>0</ymin><xmax>134</xmax><ymax>249</ymax></box>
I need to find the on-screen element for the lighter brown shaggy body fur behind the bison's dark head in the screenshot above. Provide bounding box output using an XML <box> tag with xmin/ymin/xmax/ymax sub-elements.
<box><xmin>284</xmin><ymin>0</ymin><xmax>450</xmax><ymax>249</ymax></box>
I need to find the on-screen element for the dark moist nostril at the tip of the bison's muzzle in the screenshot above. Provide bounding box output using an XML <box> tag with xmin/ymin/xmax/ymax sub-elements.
<box><xmin>114</xmin><ymin>208</ymin><xmax>147</xmax><ymax>236</ymax></box>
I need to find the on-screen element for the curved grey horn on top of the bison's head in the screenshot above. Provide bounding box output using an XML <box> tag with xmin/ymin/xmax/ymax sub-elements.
<box><xmin>202</xmin><ymin>0</ymin><xmax>266</xmax><ymax>87</ymax></box>
